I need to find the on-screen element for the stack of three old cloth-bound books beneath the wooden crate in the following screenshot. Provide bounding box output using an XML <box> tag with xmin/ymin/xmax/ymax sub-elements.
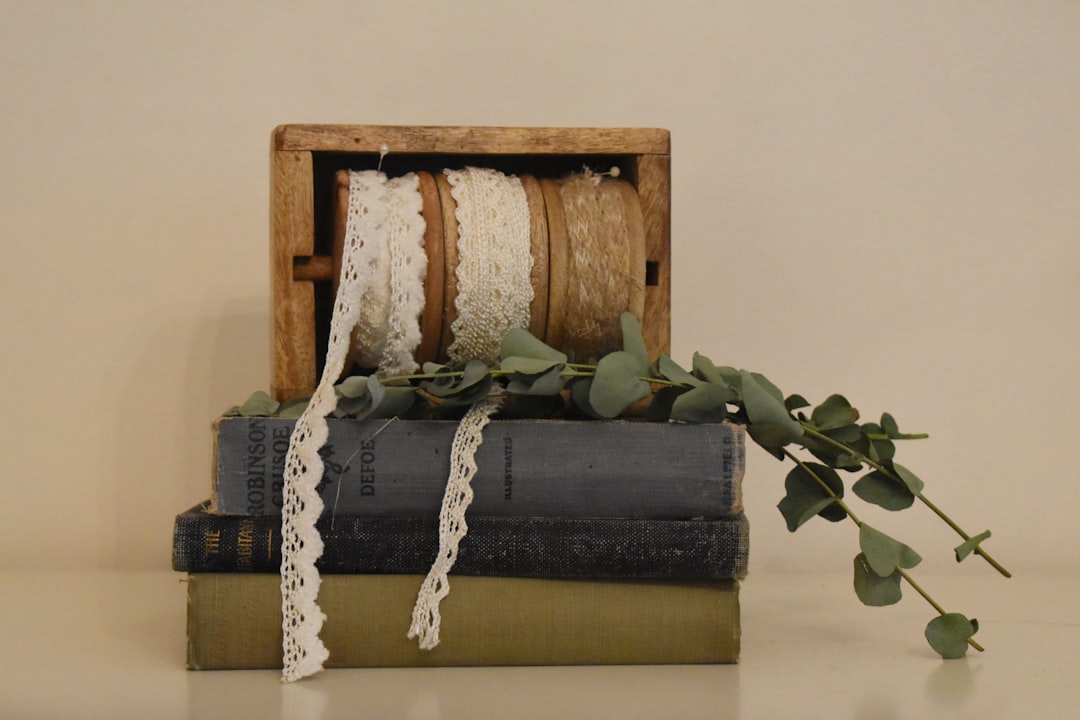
<box><xmin>173</xmin><ymin>417</ymin><xmax>748</xmax><ymax>669</ymax></box>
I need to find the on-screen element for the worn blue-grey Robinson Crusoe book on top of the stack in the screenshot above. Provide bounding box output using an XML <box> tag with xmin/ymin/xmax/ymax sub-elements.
<box><xmin>212</xmin><ymin>417</ymin><xmax>745</xmax><ymax>519</ymax></box>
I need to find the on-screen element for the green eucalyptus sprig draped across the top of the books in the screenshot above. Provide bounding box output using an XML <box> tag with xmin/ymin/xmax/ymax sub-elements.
<box><xmin>231</xmin><ymin>313</ymin><xmax>1010</xmax><ymax>657</ymax></box>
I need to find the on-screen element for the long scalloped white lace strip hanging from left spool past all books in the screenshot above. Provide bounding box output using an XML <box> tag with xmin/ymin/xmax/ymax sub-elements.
<box><xmin>281</xmin><ymin>171</ymin><xmax>422</xmax><ymax>682</ymax></box>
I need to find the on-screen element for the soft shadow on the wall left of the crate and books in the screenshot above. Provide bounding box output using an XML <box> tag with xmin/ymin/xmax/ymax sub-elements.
<box><xmin>100</xmin><ymin>297</ymin><xmax>270</xmax><ymax>570</ymax></box>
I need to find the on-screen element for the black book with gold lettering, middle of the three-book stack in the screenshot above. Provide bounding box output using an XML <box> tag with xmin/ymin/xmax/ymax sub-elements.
<box><xmin>173</xmin><ymin>503</ymin><xmax>750</xmax><ymax>580</ymax></box>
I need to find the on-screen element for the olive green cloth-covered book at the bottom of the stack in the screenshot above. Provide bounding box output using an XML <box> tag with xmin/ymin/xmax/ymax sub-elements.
<box><xmin>187</xmin><ymin>573</ymin><xmax>740</xmax><ymax>670</ymax></box>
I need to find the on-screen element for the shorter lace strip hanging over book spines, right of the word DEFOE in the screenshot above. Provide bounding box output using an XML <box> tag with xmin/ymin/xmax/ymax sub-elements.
<box><xmin>408</xmin><ymin>398</ymin><xmax>499</xmax><ymax>650</ymax></box>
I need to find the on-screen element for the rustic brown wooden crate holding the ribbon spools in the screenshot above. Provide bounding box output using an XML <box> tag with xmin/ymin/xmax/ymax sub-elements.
<box><xmin>270</xmin><ymin>125</ymin><xmax>671</xmax><ymax>399</ymax></box>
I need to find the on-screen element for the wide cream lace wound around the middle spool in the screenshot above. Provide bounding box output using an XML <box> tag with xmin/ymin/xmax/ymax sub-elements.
<box><xmin>445</xmin><ymin>167</ymin><xmax>532</xmax><ymax>365</ymax></box>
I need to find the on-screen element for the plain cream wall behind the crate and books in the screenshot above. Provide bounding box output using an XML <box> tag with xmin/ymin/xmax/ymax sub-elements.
<box><xmin>0</xmin><ymin>0</ymin><xmax>1080</xmax><ymax>573</ymax></box>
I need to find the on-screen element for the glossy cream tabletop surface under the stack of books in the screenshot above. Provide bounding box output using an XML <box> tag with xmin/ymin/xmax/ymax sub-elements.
<box><xmin>0</xmin><ymin>572</ymin><xmax>1080</xmax><ymax>720</ymax></box>
